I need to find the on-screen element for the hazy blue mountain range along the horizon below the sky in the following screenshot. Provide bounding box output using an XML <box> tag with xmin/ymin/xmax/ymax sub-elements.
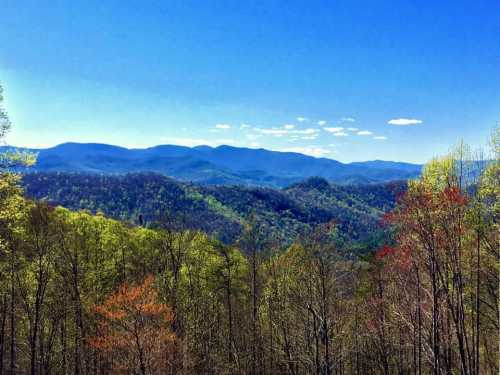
<box><xmin>0</xmin><ymin>143</ymin><xmax>422</xmax><ymax>187</ymax></box>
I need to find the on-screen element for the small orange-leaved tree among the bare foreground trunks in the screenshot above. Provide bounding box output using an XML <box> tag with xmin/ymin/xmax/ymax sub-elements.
<box><xmin>89</xmin><ymin>276</ymin><xmax>177</xmax><ymax>375</ymax></box>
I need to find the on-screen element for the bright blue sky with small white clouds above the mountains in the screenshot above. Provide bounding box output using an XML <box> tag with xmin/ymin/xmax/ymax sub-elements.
<box><xmin>0</xmin><ymin>0</ymin><xmax>500</xmax><ymax>162</ymax></box>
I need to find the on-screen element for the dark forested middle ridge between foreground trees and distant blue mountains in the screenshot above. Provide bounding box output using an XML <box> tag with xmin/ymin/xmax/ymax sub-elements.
<box><xmin>22</xmin><ymin>172</ymin><xmax>406</xmax><ymax>250</ymax></box>
